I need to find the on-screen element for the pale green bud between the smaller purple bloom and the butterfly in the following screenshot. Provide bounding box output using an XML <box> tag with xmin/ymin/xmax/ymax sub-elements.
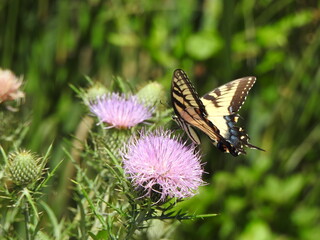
<box><xmin>137</xmin><ymin>82</ymin><xmax>166</xmax><ymax>110</ymax></box>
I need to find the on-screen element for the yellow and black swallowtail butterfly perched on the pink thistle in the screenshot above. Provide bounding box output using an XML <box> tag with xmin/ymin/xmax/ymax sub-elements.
<box><xmin>171</xmin><ymin>69</ymin><xmax>264</xmax><ymax>156</ymax></box>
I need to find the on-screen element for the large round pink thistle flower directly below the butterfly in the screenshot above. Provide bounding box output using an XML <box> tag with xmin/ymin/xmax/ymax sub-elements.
<box><xmin>122</xmin><ymin>129</ymin><xmax>204</xmax><ymax>202</ymax></box>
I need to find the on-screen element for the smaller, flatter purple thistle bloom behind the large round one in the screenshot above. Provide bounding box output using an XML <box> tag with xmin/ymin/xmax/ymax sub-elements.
<box><xmin>90</xmin><ymin>93</ymin><xmax>154</xmax><ymax>128</ymax></box>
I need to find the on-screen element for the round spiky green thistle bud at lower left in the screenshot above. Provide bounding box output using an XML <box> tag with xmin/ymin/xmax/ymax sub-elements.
<box><xmin>7</xmin><ymin>150</ymin><xmax>43</xmax><ymax>186</ymax></box>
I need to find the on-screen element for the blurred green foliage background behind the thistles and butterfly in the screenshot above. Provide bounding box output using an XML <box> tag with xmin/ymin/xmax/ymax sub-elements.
<box><xmin>0</xmin><ymin>0</ymin><xmax>320</xmax><ymax>240</ymax></box>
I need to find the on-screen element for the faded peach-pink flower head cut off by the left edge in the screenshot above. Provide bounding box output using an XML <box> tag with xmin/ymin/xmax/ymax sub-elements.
<box><xmin>0</xmin><ymin>68</ymin><xmax>24</xmax><ymax>103</ymax></box>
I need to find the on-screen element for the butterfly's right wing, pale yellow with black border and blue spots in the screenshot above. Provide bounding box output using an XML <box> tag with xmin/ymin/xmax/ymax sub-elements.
<box><xmin>200</xmin><ymin>77</ymin><xmax>262</xmax><ymax>154</ymax></box>
